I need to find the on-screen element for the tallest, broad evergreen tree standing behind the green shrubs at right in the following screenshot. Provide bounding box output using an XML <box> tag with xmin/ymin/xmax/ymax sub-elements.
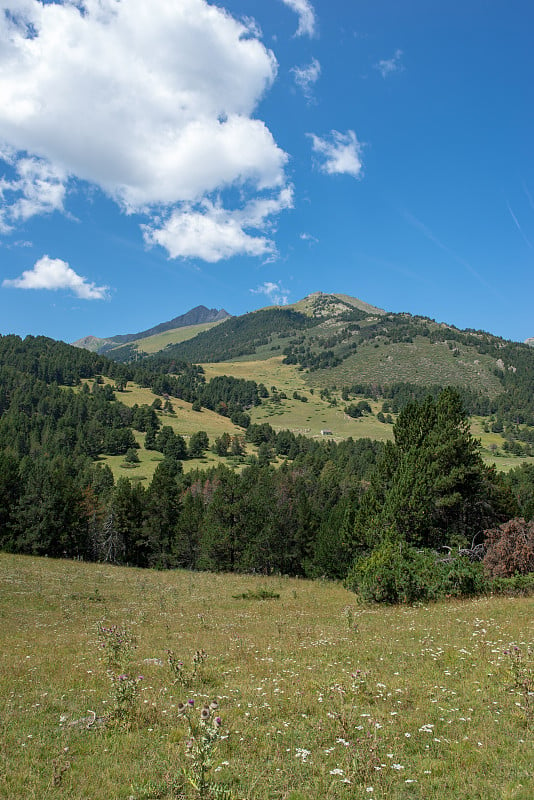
<box><xmin>353</xmin><ymin>389</ymin><xmax>494</xmax><ymax>547</ymax></box>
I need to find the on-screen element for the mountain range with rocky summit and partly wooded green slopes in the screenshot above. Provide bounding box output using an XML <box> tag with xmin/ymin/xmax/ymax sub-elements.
<box><xmin>68</xmin><ymin>292</ymin><xmax>534</xmax><ymax>434</ymax></box>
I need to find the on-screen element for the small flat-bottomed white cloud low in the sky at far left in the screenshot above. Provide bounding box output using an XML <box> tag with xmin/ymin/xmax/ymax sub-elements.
<box><xmin>2</xmin><ymin>256</ymin><xmax>109</xmax><ymax>300</ymax></box>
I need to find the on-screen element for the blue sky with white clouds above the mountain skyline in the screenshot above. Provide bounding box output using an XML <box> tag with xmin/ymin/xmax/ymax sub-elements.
<box><xmin>0</xmin><ymin>0</ymin><xmax>534</xmax><ymax>341</ymax></box>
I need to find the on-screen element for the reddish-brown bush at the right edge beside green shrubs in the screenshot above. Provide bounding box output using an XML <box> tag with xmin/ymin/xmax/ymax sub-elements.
<box><xmin>484</xmin><ymin>518</ymin><xmax>534</xmax><ymax>578</ymax></box>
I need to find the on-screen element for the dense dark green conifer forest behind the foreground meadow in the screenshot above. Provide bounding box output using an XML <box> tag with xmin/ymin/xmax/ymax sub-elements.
<box><xmin>0</xmin><ymin>337</ymin><xmax>534</xmax><ymax>578</ymax></box>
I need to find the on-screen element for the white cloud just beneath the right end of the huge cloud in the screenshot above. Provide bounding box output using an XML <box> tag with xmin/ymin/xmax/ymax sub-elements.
<box><xmin>144</xmin><ymin>187</ymin><xmax>293</xmax><ymax>263</ymax></box>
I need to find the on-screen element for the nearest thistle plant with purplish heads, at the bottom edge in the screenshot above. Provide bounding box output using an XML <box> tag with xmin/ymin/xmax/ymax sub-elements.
<box><xmin>178</xmin><ymin>700</ymin><xmax>231</xmax><ymax>800</ymax></box>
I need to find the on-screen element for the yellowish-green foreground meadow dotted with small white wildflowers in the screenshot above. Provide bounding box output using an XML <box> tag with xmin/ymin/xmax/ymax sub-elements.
<box><xmin>0</xmin><ymin>554</ymin><xmax>534</xmax><ymax>800</ymax></box>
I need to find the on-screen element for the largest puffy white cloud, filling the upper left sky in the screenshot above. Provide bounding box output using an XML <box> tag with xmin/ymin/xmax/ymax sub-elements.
<box><xmin>0</xmin><ymin>0</ymin><xmax>294</xmax><ymax>255</ymax></box>
